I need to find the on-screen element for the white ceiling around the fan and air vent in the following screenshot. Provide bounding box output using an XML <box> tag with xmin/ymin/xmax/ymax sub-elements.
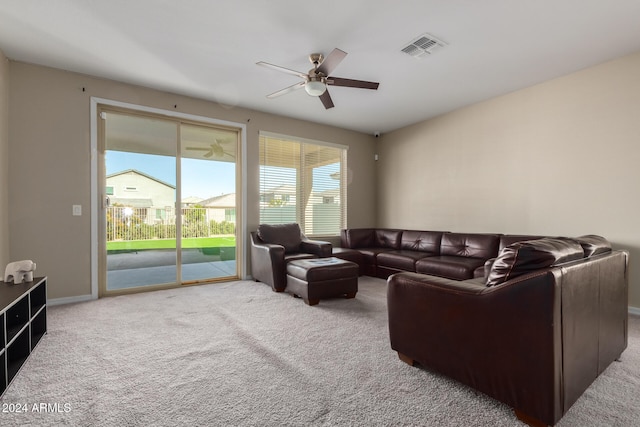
<box><xmin>0</xmin><ymin>0</ymin><xmax>640</xmax><ymax>133</ymax></box>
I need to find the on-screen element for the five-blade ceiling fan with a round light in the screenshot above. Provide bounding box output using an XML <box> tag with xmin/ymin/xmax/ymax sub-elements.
<box><xmin>256</xmin><ymin>48</ymin><xmax>379</xmax><ymax>109</ymax></box>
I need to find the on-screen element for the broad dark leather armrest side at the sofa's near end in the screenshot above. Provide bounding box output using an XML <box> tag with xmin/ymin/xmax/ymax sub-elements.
<box><xmin>387</xmin><ymin>270</ymin><xmax>563</xmax><ymax>424</ymax></box>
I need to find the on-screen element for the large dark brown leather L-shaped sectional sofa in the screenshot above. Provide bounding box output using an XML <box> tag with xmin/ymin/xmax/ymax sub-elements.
<box><xmin>342</xmin><ymin>229</ymin><xmax>628</xmax><ymax>425</ymax></box>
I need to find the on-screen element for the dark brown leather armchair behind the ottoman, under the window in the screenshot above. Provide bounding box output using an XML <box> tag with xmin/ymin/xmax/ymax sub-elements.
<box><xmin>251</xmin><ymin>223</ymin><xmax>332</xmax><ymax>292</ymax></box>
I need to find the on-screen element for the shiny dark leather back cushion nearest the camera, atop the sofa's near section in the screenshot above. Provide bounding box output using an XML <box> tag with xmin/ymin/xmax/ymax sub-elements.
<box><xmin>487</xmin><ymin>237</ymin><xmax>584</xmax><ymax>286</ymax></box>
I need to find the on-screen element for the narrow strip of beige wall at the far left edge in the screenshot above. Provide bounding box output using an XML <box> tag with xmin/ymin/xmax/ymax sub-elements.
<box><xmin>0</xmin><ymin>51</ymin><xmax>11</xmax><ymax>270</ymax></box>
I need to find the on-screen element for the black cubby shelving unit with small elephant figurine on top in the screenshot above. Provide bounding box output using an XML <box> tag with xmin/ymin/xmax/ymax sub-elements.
<box><xmin>0</xmin><ymin>277</ymin><xmax>47</xmax><ymax>395</ymax></box>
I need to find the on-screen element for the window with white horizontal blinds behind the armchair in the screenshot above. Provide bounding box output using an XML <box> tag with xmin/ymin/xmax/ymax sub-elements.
<box><xmin>260</xmin><ymin>133</ymin><xmax>347</xmax><ymax>236</ymax></box>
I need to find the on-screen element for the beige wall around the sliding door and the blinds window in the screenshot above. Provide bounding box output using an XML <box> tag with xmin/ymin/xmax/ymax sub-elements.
<box><xmin>9</xmin><ymin>62</ymin><xmax>376</xmax><ymax>298</ymax></box>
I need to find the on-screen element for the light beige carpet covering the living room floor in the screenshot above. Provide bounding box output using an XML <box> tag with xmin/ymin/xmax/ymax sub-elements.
<box><xmin>0</xmin><ymin>278</ymin><xmax>640</xmax><ymax>427</ymax></box>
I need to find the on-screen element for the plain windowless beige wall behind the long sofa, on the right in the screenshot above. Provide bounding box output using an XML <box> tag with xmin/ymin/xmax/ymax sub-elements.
<box><xmin>378</xmin><ymin>53</ymin><xmax>640</xmax><ymax>307</ymax></box>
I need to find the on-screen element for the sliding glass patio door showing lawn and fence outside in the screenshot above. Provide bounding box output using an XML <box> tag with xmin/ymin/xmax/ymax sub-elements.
<box><xmin>99</xmin><ymin>107</ymin><xmax>239</xmax><ymax>295</ymax></box>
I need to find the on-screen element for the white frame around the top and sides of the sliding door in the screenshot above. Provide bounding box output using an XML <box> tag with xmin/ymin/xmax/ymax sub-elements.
<box><xmin>90</xmin><ymin>97</ymin><xmax>248</xmax><ymax>299</ymax></box>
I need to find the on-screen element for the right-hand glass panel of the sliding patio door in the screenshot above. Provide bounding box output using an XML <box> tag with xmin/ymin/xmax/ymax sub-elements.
<box><xmin>180</xmin><ymin>124</ymin><xmax>238</xmax><ymax>282</ymax></box>
